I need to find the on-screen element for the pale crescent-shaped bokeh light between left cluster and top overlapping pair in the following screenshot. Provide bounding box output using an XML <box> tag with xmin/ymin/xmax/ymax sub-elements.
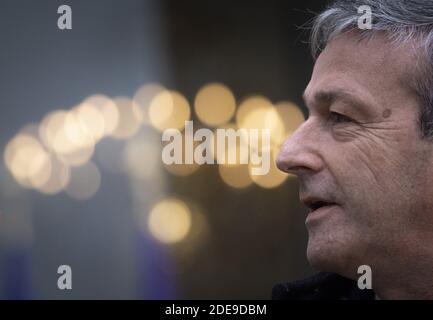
<box><xmin>111</xmin><ymin>97</ymin><xmax>143</xmax><ymax>139</ymax></box>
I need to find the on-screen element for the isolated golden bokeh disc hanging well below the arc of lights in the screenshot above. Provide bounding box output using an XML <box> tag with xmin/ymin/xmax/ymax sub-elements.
<box><xmin>147</xmin><ymin>199</ymin><xmax>192</xmax><ymax>244</ymax></box>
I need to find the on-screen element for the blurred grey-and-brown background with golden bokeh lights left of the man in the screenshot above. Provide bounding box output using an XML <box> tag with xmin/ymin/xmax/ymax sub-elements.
<box><xmin>0</xmin><ymin>0</ymin><xmax>327</xmax><ymax>299</ymax></box>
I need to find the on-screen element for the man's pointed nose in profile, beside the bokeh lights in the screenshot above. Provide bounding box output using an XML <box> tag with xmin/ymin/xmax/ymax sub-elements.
<box><xmin>276</xmin><ymin>119</ymin><xmax>323</xmax><ymax>177</ymax></box>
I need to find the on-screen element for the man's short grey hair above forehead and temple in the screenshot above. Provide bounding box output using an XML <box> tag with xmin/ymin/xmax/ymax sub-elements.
<box><xmin>310</xmin><ymin>0</ymin><xmax>433</xmax><ymax>138</ymax></box>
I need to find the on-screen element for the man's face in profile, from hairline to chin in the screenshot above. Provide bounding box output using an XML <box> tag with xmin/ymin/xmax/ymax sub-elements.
<box><xmin>277</xmin><ymin>34</ymin><xmax>433</xmax><ymax>278</ymax></box>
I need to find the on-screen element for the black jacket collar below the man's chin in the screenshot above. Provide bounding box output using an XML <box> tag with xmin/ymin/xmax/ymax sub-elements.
<box><xmin>272</xmin><ymin>272</ymin><xmax>375</xmax><ymax>300</ymax></box>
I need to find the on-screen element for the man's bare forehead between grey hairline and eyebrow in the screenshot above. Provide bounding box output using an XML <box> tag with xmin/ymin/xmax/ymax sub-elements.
<box><xmin>304</xmin><ymin>34</ymin><xmax>413</xmax><ymax>107</ymax></box>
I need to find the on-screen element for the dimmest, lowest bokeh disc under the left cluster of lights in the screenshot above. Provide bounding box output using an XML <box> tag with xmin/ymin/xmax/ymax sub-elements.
<box><xmin>65</xmin><ymin>162</ymin><xmax>101</xmax><ymax>200</ymax></box>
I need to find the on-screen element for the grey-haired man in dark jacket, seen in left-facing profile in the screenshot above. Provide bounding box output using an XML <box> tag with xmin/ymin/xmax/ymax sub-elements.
<box><xmin>273</xmin><ymin>0</ymin><xmax>433</xmax><ymax>299</ymax></box>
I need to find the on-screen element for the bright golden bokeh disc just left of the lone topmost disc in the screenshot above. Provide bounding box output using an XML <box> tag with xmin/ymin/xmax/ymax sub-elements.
<box><xmin>149</xmin><ymin>90</ymin><xmax>191</xmax><ymax>132</ymax></box>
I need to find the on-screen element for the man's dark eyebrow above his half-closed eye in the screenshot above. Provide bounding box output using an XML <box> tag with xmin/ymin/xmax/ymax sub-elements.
<box><xmin>302</xmin><ymin>89</ymin><xmax>374</xmax><ymax>115</ymax></box>
